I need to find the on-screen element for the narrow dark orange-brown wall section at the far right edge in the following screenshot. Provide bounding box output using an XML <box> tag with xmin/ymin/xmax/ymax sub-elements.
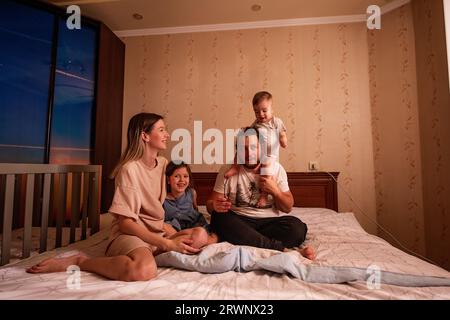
<box><xmin>412</xmin><ymin>0</ymin><xmax>450</xmax><ymax>270</ymax></box>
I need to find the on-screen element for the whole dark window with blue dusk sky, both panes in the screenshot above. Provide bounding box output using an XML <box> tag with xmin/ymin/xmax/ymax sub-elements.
<box><xmin>0</xmin><ymin>0</ymin><xmax>98</xmax><ymax>164</ymax></box>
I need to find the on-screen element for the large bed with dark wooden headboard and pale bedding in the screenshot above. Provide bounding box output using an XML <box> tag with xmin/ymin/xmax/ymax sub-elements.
<box><xmin>0</xmin><ymin>168</ymin><xmax>450</xmax><ymax>300</ymax></box>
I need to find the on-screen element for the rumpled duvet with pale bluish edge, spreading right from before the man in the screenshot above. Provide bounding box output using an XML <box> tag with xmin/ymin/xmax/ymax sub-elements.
<box><xmin>156</xmin><ymin>209</ymin><xmax>450</xmax><ymax>287</ymax></box>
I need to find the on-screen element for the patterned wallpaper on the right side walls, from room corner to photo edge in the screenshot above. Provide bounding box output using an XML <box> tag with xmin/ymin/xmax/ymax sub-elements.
<box><xmin>368</xmin><ymin>0</ymin><xmax>450</xmax><ymax>269</ymax></box>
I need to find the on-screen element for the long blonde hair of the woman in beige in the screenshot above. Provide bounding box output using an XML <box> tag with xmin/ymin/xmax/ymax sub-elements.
<box><xmin>111</xmin><ymin>112</ymin><xmax>163</xmax><ymax>178</ymax></box>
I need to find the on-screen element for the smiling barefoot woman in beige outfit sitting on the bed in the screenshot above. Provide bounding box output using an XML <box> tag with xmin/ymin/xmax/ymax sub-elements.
<box><xmin>27</xmin><ymin>113</ymin><xmax>208</xmax><ymax>281</ymax></box>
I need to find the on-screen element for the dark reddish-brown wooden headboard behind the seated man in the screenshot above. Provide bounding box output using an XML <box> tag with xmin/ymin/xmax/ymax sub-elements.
<box><xmin>192</xmin><ymin>172</ymin><xmax>339</xmax><ymax>211</ymax></box>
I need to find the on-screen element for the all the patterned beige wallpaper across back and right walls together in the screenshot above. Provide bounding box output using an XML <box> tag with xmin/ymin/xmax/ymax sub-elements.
<box><xmin>119</xmin><ymin>0</ymin><xmax>450</xmax><ymax>269</ymax></box>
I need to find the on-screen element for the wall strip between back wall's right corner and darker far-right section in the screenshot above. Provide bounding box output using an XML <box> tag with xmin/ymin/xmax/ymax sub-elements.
<box><xmin>367</xmin><ymin>5</ymin><xmax>425</xmax><ymax>254</ymax></box>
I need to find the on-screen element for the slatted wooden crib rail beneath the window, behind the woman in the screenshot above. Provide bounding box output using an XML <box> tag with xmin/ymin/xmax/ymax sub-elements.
<box><xmin>0</xmin><ymin>163</ymin><xmax>102</xmax><ymax>266</ymax></box>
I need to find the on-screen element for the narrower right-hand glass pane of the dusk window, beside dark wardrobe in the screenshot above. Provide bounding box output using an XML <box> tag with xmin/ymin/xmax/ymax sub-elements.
<box><xmin>50</xmin><ymin>18</ymin><xmax>97</xmax><ymax>164</ymax></box>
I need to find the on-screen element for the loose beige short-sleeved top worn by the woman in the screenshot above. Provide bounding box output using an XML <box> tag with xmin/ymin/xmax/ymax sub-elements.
<box><xmin>109</xmin><ymin>157</ymin><xmax>167</xmax><ymax>243</ymax></box>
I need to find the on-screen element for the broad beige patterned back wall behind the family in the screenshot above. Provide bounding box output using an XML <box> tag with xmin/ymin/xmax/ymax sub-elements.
<box><xmin>123</xmin><ymin>23</ymin><xmax>376</xmax><ymax>232</ymax></box>
